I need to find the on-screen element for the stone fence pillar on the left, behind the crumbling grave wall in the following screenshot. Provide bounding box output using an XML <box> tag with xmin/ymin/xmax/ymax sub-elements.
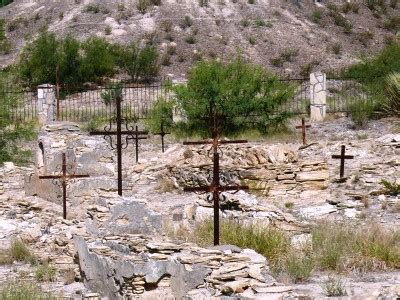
<box><xmin>37</xmin><ymin>84</ymin><xmax>56</xmax><ymax>126</ymax></box>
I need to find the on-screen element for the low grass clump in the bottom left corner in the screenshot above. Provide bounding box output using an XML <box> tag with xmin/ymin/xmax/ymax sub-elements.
<box><xmin>0</xmin><ymin>281</ymin><xmax>60</xmax><ymax>300</ymax></box>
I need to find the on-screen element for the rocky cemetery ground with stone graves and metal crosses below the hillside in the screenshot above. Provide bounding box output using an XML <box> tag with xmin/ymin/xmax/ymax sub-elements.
<box><xmin>0</xmin><ymin>65</ymin><xmax>400</xmax><ymax>299</ymax></box>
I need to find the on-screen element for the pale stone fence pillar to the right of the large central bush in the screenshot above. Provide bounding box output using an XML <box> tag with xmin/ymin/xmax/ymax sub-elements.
<box><xmin>310</xmin><ymin>72</ymin><xmax>326</xmax><ymax>122</ymax></box>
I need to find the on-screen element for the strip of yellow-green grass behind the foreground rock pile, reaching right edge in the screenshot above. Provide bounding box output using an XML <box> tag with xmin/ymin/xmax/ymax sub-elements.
<box><xmin>175</xmin><ymin>220</ymin><xmax>400</xmax><ymax>282</ymax></box>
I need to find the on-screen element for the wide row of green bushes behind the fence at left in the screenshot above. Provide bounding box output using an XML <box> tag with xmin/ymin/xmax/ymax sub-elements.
<box><xmin>16</xmin><ymin>29</ymin><xmax>159</xmax><ymax>85</ymax></box>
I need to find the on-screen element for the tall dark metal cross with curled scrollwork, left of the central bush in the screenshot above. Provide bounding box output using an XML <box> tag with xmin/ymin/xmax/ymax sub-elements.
<box><xmin>90</xmin><ymin>96</ymin><xmax>148</xmax><ymax>196</ymax></box>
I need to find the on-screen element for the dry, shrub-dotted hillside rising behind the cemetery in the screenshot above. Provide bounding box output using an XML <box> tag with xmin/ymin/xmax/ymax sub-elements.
<box><xmin>0</xmin><ymin>0</ymin><xmax>400</xmax><ymax>77</ymax></box>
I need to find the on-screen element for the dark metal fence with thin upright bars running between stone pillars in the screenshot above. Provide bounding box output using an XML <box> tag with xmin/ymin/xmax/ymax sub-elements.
<box><xmin>0</xmin><ymin>72</ymin><xmax>384</xmax><ymax>123</ymax></box>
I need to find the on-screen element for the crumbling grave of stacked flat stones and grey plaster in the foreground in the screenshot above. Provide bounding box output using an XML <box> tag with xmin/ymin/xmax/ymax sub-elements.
<box><xmin>74</xmin><ymin>234</ymin><xmax>291</xmax><ymax>299</ymax></box>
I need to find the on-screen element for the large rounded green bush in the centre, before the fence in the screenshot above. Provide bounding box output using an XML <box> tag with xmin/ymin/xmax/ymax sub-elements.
<box><xmin>173</xmin><ymin>57</ymin><xmax>294</xmax><ymax>134</ymax></box>
